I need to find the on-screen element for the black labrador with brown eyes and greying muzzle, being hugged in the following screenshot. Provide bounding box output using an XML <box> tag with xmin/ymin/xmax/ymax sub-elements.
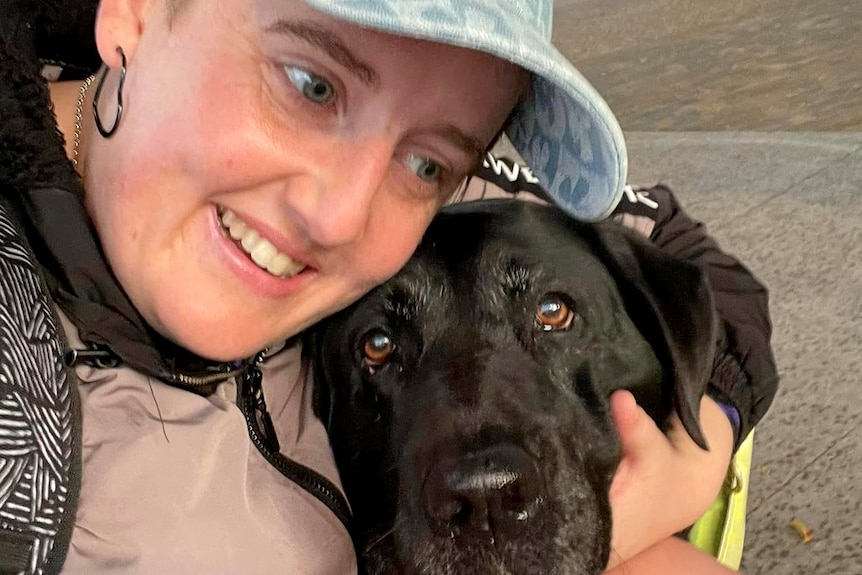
<box><xmin>309</xmin><ymin>200</ymin><xmax>716</xmax><ymax>575</ymax></box>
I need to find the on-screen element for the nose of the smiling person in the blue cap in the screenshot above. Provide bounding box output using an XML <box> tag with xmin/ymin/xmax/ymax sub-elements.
<box><xmin>293</xmin><ymin>140</ymin><xmax>394</xmax><ymax>247</ymax></box>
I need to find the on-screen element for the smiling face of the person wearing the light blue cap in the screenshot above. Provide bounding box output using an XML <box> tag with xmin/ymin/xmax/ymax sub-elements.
<box><xmin>86</xmin><ymin>0</ymin><xmax>525</xmax><ymax>360</ymax></box>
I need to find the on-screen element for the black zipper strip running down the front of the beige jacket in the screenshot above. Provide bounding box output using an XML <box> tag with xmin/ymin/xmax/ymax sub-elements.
<box><xmin>240</xmin><ymin>354</ymin><xmax>355</xmax><ymax>541</ymax></box>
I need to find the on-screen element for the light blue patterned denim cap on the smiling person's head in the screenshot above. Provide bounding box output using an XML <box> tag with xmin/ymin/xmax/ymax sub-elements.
<box><xmin>306</xmin><ymin>0</ymin><xmax>628</xmax><ymax>221</ymax></box>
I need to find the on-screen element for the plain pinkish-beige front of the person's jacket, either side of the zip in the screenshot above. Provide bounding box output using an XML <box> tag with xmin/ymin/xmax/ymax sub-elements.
<box><xmin>63</xmin><ymin>317</ymin><xmax>356</xmax><ymax>575</ymax></box>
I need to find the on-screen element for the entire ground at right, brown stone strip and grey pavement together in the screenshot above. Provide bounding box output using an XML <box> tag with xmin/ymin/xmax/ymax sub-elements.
<box><xmin>555</xmin><ymin>0</ymin><xmax>862</xmax><ymax>575</ymax></box>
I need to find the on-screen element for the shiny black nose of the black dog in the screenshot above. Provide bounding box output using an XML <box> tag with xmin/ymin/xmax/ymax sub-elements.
<box><xmin>422</xmin><ymin>443</ymin><xmax>544</xmax><ymax>544</ymax></box>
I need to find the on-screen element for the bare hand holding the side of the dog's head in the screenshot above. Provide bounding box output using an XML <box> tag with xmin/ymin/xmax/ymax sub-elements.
<box><xmin>608</xmin><ymin>391</ymin><xmax>733</xmax><ymax>568</ymax></box>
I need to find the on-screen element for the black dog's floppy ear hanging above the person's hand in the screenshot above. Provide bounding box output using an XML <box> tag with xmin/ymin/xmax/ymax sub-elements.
<box><xmin>596</xmin><ymin>222</ymin><xmax>718</xmax><ymax>449</ymax></box>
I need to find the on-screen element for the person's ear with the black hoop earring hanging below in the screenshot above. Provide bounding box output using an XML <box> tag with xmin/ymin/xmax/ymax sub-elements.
<box><xmin>96</xmin><ymin>0</ymin><xmax>162</xmax><ymax>68</ymax></box>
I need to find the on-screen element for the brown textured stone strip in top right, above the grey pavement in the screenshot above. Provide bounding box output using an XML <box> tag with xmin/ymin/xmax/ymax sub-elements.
<box><xmin>554</xmin><ymin>0</ymin><xmax>862</xmax><ymax>131</ymax></box>
